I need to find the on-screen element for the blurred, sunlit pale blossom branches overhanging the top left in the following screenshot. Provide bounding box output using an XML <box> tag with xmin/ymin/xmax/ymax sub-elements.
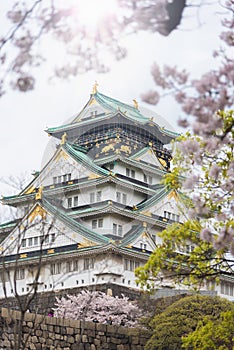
<box><xmin>0</xmin><ymin>0</ymin><xmax>192</xmax><ymax>96</ymax></box>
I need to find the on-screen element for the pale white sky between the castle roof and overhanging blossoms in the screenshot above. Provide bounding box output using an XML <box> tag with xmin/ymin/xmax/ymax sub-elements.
<box><xmin>0</xmin><ymin>1</ymin><xmax>221</xmax><ymax>222</ymax></box>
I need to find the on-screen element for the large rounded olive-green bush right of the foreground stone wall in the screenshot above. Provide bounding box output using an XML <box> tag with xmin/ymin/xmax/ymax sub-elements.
<box><xmin>145</xmin><ymin>295</ymin><xmax>234</xmax><ymax>350</ymax></box>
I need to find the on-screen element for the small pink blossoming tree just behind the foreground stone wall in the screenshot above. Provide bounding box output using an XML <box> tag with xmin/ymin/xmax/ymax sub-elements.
<box><xmin>53</xmin><ymin>290</ymin><xmax>142</xmax><ymax>327</ymax></box>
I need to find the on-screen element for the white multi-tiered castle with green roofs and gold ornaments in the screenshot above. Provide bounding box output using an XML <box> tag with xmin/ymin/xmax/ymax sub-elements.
<box><xmin>0</xmin><ymin>85</ymin><xmax>233</xmax><ymax>299</ymax></box>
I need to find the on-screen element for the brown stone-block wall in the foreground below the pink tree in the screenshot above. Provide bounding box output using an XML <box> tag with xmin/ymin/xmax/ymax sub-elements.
<box><xmin>0</xmin><ymin>308</ymin><xmax>148</xmax><ymax>350</ymax></box>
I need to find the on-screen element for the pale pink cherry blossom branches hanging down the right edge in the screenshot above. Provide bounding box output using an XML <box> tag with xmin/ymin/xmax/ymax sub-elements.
<box><xmin>142</xmin><ymin>0</ymin><xmax>234</xmax><ymax>254</ymax></box>
